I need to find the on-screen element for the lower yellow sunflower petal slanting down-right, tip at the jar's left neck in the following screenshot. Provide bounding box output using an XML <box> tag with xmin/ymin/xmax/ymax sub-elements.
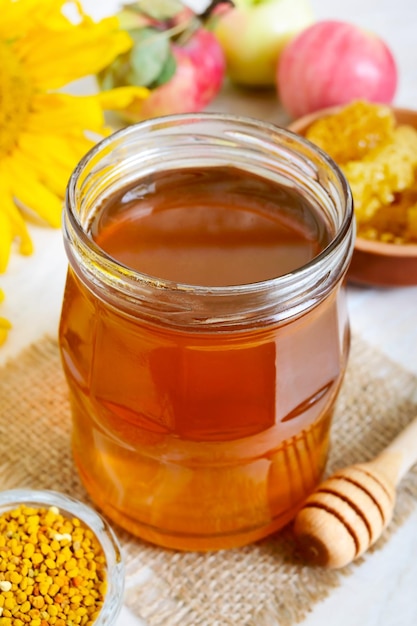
<box><xmin>4</xmin><ymin>151</ymin><xmax>63</xmax><ymax>228</ymax></box>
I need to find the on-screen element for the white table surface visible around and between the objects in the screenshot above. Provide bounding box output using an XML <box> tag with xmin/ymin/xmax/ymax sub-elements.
<box><xmin>0</xmin><ymin>0</ymin><xmax>417</xmax><ymax>626</ymax></box>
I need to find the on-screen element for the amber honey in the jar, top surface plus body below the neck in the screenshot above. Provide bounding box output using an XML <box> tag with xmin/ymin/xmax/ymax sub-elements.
<box><xmin>60</xmin><ymin>168</ymin><xmax>348</xmax><ymax>550</ymax></box>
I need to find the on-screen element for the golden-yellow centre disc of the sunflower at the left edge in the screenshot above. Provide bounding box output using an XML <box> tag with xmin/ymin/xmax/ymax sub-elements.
<box><xmin>0</xmin><ymin>41</ymin><xmax>33</xmax><ymax>157</ymax></box>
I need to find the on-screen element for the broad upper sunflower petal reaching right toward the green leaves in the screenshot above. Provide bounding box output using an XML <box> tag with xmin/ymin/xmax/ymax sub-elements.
<box><xmin>17</xmin><ymin>17</ymin><xmax>132</xmax><ymax>90</ymax></box>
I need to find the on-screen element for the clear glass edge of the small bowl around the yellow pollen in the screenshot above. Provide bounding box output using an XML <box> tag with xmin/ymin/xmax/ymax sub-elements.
<box><xmin>0</xmin><ymin>489</ymin><xmax>124</xmax><ymax>626</ymax></box>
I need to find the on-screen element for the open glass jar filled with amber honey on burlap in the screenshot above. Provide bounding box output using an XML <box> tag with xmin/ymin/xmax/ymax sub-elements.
<box><xmin>60</xmin><ymin>113</ymin><xmax>354</xmax><ymax>550</ymax></box>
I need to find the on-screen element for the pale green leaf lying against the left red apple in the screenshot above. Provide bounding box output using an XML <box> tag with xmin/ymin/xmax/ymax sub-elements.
<box><xmin>127</xmin><ymin>28</ymin><xmax>170</xmax><ymax>87</ymax></box>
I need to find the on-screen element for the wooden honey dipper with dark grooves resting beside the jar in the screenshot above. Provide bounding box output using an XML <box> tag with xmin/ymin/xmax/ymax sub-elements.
<box><xmin>294</xmin><ymin>418</ymin><xmax>417</xmax><ymax>568</ymax></box>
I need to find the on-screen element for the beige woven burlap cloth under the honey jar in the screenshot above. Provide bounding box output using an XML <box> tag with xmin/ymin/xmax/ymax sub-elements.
<box><xmin>0</xmin><ymin>337</ymin><xmax>417</xmax><ymax>626</ymax></box>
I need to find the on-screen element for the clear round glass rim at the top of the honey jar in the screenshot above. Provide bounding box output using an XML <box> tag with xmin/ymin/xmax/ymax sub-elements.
<box><xmin>66</xmin><ymin>111</ymin><xmax>354</xmax><ymax>296</ymax></box>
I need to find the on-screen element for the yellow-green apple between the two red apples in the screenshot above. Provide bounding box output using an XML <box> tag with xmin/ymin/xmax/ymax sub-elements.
<box><xmin>213</xmin><ymin>0</ymin><xmax>314</xmax><ymax>87</ymax></box>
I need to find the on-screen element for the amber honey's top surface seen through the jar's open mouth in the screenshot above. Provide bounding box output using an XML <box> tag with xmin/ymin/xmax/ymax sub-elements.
<box><xmin>91</xmin><ymin>168</ymin><xmax>331</xmax><ymax>287</ymax></box>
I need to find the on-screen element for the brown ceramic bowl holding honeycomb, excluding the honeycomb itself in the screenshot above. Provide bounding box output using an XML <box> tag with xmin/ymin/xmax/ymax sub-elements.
<box><xmin>288</xmin><ymin>107</ymin><xmax>417</xmax><ymax>287</ymax></box>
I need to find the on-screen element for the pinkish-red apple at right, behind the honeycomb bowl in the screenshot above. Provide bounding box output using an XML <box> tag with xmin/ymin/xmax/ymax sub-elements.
<box><xmin>276</xmin><ymin>20</ymin><xmax>398</xmax><ymax>118</ymax></box>
